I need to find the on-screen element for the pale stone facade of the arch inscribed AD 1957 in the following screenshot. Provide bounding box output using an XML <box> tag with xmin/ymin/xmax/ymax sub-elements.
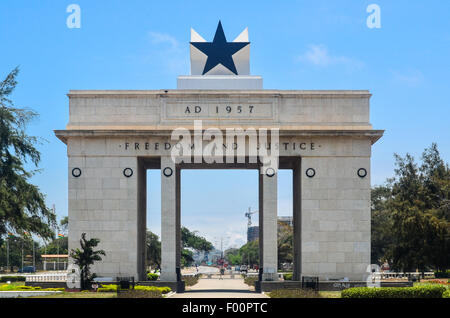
<box><xmin>55</xmin><ymin>90</ymin><xmax>383</xmax><ymax>281</ymax></box>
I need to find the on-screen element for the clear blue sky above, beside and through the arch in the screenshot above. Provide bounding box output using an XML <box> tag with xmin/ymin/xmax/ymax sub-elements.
<box><xmin>0</xmin><ymin>0</ymin><xmax>450</xmax><ymax>244</ymax></box>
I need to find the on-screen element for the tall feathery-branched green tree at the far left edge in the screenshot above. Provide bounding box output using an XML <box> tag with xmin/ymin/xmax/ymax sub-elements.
<box><xmin>0</xmin><ymin>68</ymin><xmax>56</xmax><ymax>238</ymax></box>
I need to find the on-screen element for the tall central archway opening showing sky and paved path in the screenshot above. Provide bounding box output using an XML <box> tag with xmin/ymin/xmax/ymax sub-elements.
<box><xmin>180</xmin><ymin>167</ymin><xmax>259</xmax><ymax>292</ymax></box>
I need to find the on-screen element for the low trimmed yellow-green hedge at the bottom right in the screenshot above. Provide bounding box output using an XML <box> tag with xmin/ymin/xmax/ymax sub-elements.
<box><xmin>341</xmin><ymin>285</ymin><xmax>446</xmax><ymax>298</ymax></box>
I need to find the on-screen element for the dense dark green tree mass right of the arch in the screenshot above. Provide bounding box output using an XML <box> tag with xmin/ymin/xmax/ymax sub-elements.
<box><xmin>372</xmin><ymin>144</ymin><xmax>450</xmax><ymax>271</ymax></box>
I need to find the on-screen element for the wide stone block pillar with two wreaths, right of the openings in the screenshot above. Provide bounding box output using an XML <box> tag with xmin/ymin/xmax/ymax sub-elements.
<box><xmin>301</xmin><ymin>157</ymin><xmax>370</xmax><ymax>281</ymax></box>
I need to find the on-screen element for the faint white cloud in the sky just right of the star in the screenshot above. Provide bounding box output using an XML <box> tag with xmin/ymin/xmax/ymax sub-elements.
<box><xmin>298</xmin><ymin>44</ymin><xmax>364</xmax><ymax>69</ymax></box>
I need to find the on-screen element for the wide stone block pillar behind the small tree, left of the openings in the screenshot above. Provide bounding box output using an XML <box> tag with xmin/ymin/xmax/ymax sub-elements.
<box><xmin>68</xmin><ymin>155</ymin><xmax>139</xmax><ymax>280</ymax></box>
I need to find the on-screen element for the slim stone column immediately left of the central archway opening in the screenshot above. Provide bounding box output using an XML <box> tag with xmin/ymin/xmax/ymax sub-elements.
<box><xmin>160</xmin><ymin>156</ymin><xmax>179</xmax><ymax>282</ymax></box>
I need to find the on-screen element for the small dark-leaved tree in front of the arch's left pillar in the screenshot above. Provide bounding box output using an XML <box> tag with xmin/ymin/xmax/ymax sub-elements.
<box><xmin>70</xmin><ymin>233</ymin><xmax>106</xmax><ymax>290</ymax></box>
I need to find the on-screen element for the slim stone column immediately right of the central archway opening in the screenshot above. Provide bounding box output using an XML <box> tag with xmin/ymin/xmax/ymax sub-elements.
<box><xmin>259</xmin><ymin>167</ymin><xmax>278</xmax><ymax>280</ymax></box>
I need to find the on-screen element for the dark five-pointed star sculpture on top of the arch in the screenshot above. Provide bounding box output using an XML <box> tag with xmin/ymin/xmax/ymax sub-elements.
<box><xmin>191</xmin><ymin>21</ymin><xmax>250</xmax><ymax>75</ymax></box>
